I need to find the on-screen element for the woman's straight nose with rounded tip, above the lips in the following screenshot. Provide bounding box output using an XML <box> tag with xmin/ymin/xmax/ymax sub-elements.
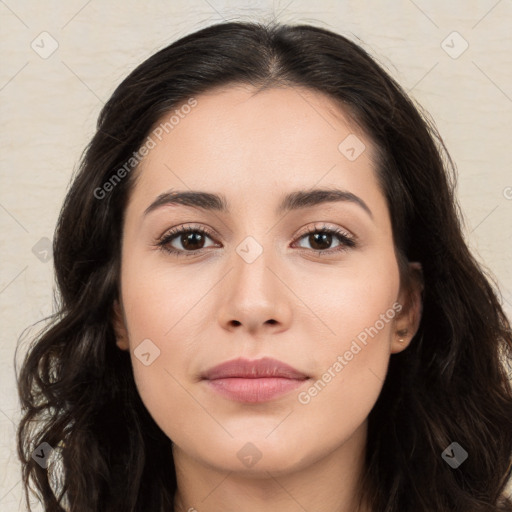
<box><xmin>218</xmin><ymin>243</ymin><xmax>293</xmax><ymax>335</ymax></box>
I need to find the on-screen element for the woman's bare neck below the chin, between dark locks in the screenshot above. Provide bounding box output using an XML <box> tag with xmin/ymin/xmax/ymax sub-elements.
<box><xmin>173</xmin><ymin>422</ymin><xmax>370</xmax><ymax>512</ymax></box>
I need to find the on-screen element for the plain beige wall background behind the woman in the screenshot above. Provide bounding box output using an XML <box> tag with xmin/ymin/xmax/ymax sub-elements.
<box><xmin>0</xmin><ymin>0</ymin><xmax>512</xmax><ymax>512</ymax></box>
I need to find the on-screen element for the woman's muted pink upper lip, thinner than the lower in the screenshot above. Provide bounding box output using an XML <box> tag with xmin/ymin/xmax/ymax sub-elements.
<box><xmin>202</xmin><ymin>357</ymin><xmax>308</xmax><ymax>380</ymax></box>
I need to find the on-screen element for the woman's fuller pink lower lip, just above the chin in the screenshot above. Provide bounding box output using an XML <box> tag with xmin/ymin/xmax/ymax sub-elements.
<box><xmin>207</xmin><ymin>377</ymin><xmax>308</xmax><ymax>403</ymax></box>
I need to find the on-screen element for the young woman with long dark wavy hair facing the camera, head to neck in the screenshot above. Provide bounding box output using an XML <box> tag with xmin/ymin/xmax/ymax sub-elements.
<box><xmin>18</xmin><ymin>22</ymin><xmax>512</xmax><ymax>512</ymax></box>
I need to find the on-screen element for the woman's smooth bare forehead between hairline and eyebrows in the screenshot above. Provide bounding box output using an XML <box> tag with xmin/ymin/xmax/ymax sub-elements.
<box><xmin>127</xmin><ymin>86</ymin><xmax>379</xmax><ymax>218</ymax></box>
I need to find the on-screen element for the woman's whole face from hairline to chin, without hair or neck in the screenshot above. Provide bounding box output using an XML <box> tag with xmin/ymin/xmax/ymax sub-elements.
<box><xmin>116</xmin><ymin>87</ymin><xmax>420</xmax><ymax>474</ymax></box>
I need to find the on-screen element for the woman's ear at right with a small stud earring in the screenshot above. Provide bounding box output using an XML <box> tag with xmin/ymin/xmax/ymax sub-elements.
<box><xmin>391</xmin><ymin>262</ymin><xmax>425</xmax><ymax>354</ymax></box>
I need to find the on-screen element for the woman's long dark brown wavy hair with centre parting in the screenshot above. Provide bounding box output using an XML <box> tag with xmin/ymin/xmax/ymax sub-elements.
<box><xmin>17</xmin><ymin>18</ymin><xmax>512</xmax><ymax>512</ymax></box>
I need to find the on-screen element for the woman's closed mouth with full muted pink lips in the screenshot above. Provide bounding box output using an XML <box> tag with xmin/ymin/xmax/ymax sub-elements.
<box><xmin>202</xmin><ymin>357</ymin><xmax>309</xmax><ymax>403</ymax></box>
